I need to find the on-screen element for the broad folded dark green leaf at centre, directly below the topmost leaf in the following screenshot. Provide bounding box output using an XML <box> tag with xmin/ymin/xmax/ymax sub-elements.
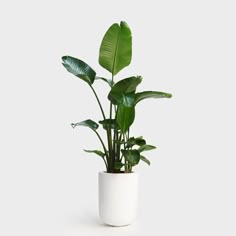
<box><xmin>108</xmin><ymin>76</ymin><xmax>142</xmax><ymax>106</ymax></box>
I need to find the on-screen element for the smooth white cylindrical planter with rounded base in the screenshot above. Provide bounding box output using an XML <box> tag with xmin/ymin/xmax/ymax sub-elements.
<box><xmin>99</xmin><ymin>172</ymin><xmax>138</xmax><ymax>226</ymax></box>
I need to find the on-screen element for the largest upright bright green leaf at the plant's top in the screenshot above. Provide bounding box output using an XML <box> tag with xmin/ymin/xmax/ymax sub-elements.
<box><xmin>99</xmin><ymin>21</ymin><xmax>132</xmax><ymax>76</ymax></box>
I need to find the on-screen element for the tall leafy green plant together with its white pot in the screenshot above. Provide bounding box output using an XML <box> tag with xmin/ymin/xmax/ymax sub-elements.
<box><xmin>62</xmin><ymin>21</ymin><xmax>171</xmax><ymax>226</ymax></box>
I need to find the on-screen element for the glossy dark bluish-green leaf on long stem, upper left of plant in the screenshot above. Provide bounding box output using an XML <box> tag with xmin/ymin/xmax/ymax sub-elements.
<box><xmin>62</xmin><ymin>56</ymin><xmax>96</xmax><ymax>85</ymax></box>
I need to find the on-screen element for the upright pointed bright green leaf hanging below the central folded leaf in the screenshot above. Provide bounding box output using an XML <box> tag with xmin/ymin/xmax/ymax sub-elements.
<box><xmin>116</xmin><ymin>104</ymin><xmax>135</xmax><ymax>133</ymax></box>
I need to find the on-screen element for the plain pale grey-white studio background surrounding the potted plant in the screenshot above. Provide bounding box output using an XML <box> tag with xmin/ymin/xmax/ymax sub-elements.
<box><xmin>0</xmin><ymin>0</ymin><xmax>236</xmax><ymax>236</ymax></box>
